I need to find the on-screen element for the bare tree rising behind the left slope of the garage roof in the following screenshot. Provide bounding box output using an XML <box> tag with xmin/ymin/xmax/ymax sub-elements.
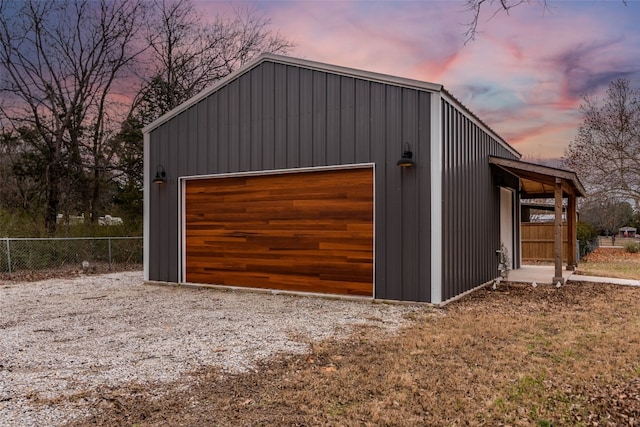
<box><xmin>135</xmin><ymin>0</ymin><xmax>293</xmax><ymax>123</ymax></box>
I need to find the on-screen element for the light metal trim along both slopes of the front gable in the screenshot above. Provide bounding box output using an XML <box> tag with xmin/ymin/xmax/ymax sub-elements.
<box><xmin>142</xmin><ymin>53</ymin><xmax>442</xmax><ymax>133</ymax></box>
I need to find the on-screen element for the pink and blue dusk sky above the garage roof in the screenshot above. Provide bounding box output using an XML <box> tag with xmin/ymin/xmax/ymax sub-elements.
<box><xmin>195</xmin><ymin>0</ymin><xmax>640</xmax><ymax>158</ymax></box>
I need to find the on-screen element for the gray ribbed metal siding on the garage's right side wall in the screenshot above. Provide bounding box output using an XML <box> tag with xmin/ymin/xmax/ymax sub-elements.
<box><xmin>442</xmin><ymin>100</ymin><xmax>518</xmax><ymax>300</ymax></box>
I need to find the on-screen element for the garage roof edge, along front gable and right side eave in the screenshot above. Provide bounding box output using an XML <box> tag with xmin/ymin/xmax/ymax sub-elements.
<box><xmin>142</xmin><ymin>53</ymin><xmax>522</xmax><ymax>157</ymax></box>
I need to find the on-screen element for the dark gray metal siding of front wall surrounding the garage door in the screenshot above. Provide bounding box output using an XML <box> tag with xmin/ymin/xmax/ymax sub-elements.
<box><xmin>149</xmin><ymin>61</ymin><xmax>431</xmax><ymax>301</ymax></box>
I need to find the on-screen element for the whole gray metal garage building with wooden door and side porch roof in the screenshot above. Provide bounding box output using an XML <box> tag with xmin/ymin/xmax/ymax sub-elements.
<box><xmin>144</xmin><ymin>54</ymin><xmax>581</xmax><ymax>303</ymax></box>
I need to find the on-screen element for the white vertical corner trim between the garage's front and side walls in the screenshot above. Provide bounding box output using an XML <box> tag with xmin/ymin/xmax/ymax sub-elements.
<box><xmin>431</xmin><ymin>93</ymin><xmax>442</xmax><ymax>304</ymax></box>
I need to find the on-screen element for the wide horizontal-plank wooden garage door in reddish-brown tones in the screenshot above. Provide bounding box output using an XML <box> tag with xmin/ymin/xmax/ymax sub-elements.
<box><xmin>185</xmin><ymin>167</ymin><xmax>373</xmax><ymax>296</ymax></box>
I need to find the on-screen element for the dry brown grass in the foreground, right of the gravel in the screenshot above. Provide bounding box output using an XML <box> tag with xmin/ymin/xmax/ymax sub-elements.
<box><xmin>66</xmin><ymin>283</ymin><xmax>640</xmax><ymax>426</ymax></box>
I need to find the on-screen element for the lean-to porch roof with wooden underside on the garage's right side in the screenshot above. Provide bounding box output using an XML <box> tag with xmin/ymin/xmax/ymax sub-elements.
<box><xmin>489</xmin><ymin>156</ymin><xmax>587</xmax><ymax>199</ymax></box>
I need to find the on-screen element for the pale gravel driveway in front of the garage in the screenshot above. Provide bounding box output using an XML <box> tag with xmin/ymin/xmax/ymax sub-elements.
<box><xmin>0</xmin><ymin>272</ymin><xmax>423</xmax><ymax>426</ymax></box>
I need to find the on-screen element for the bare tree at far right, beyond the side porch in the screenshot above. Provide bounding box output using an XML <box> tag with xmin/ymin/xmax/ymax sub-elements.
<box><xmin>564</xmin><ymin>79</ymin><xmax>640</xmax><ymax>209</ymax></box>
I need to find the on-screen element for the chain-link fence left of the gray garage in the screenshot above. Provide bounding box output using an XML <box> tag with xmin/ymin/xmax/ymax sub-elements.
<box><xmin>0</xmin><ymin>237</ymin><xmax>143</xmax><ymax>278</ymax></box>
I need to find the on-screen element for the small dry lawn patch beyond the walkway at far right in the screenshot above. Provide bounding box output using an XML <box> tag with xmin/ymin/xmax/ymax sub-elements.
<box><xmin>577</xmin><ymin>247</ymin><xmax>640</xmax><ymax>280</ymax></box>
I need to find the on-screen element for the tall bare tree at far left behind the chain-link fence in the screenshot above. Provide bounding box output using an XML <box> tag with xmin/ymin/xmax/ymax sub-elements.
<box><xmin>0</xmin><ymin>0</ymin><xmax>149</xmax><ymax>233</ymax></box>
